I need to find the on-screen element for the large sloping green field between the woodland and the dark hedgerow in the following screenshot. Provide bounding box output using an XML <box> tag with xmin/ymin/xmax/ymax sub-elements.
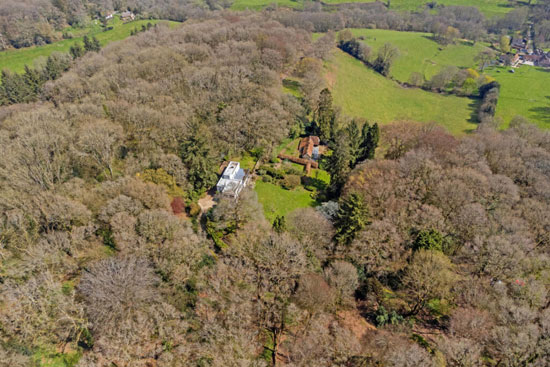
<box><xmin>325</xmin><ymin>50</ymin><xmax>477</xmax><ymax>134</ymax></box>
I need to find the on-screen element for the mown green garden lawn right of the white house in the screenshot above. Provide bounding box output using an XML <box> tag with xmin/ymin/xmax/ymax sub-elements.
<box><xmin>255</xmin><ymin>180</ymin><xmax>317</xmax><ymax>222</ymax></box>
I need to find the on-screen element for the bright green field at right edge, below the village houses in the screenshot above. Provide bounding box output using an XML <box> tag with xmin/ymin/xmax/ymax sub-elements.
<box><xmin>485</xmin><ymin>65</ymin><xmax>550</xmax><ymax>129</ymax></box>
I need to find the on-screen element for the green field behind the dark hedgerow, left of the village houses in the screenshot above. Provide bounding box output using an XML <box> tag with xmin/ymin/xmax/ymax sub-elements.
<box><xmin>344</xmin><ymin>29</ymin><xmax>492</xmax><ymax>82</ymax></box>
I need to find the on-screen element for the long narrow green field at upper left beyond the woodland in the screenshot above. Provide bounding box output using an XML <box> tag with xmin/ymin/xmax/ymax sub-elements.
<box><xmin>0</xmin><ymin>20</ymin><xmax>179</xmax><ymax>72</ymax></box>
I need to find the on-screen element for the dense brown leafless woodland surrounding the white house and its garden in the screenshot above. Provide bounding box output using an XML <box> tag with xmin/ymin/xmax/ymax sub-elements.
<box><xmin>0</xmin><ymin>2</ymin><xmax>550</xmax><ymax>367</ymax></box>
